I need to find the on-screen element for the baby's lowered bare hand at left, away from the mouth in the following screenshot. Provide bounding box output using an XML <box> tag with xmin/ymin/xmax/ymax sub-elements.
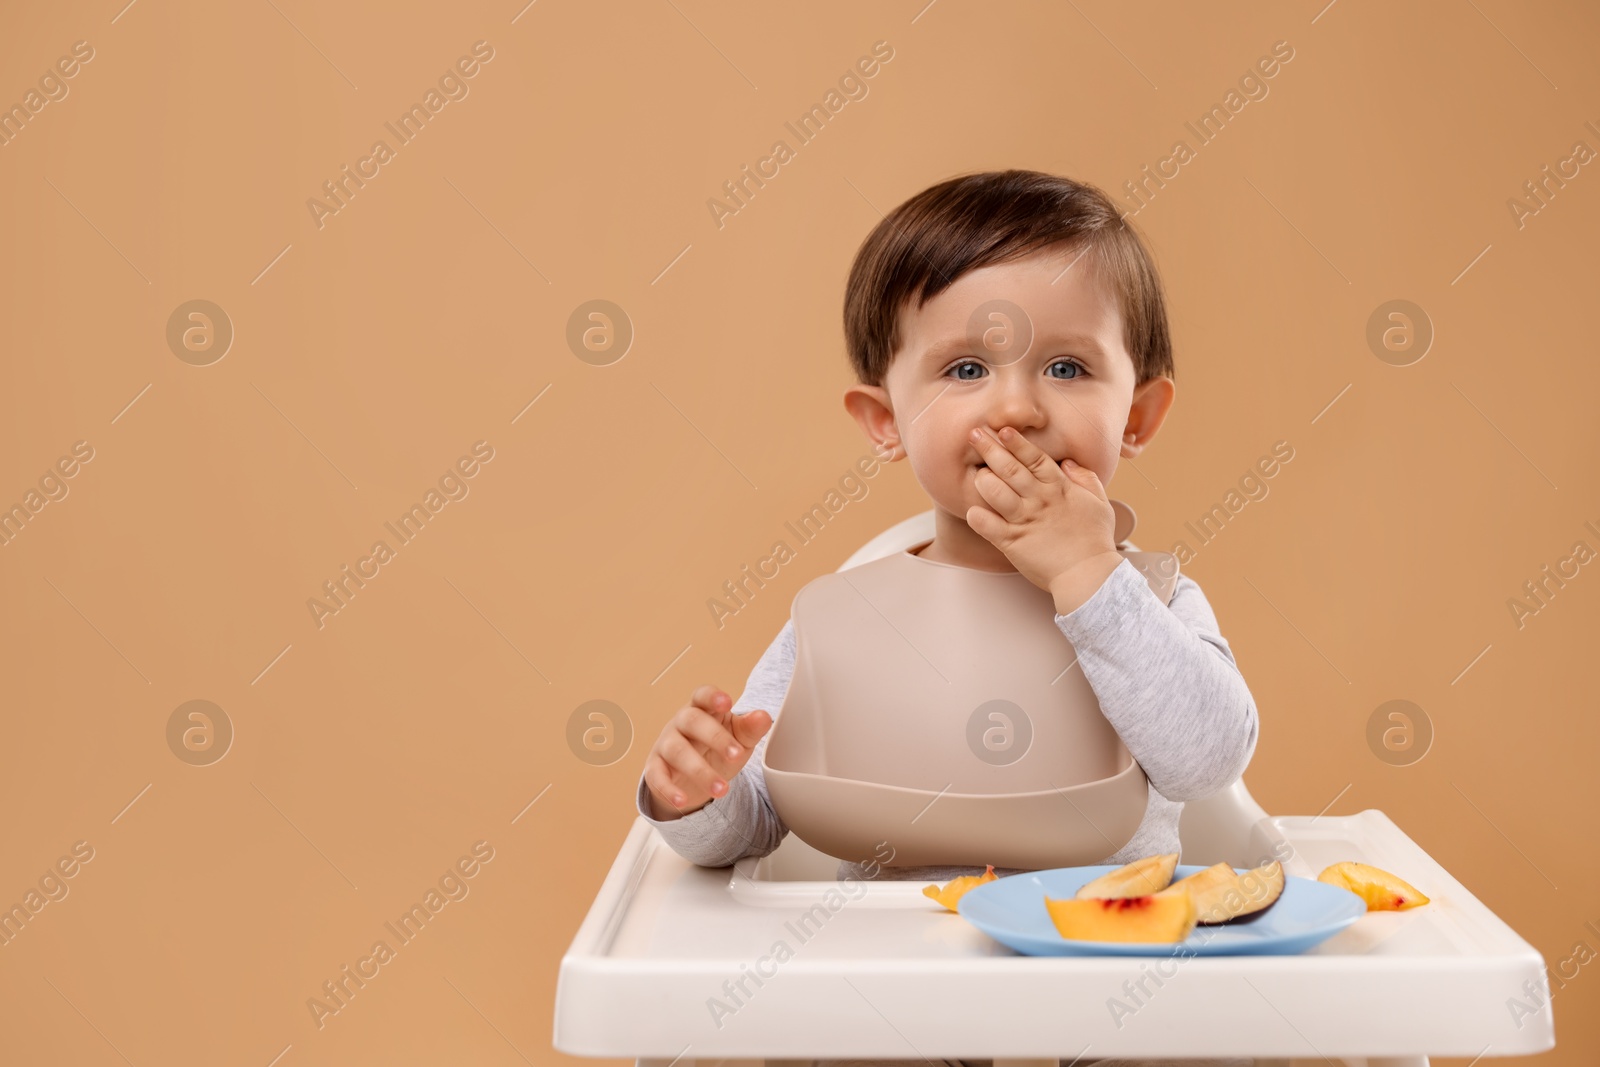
<box><xmin>645</xmin><ymin>685</ymin><xmax>773</xmax><ymax>821</ymax></box>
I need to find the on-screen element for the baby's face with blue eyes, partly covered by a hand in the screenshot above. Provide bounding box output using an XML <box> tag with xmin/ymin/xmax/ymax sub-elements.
<box><xmin>883</xmin><ymin>253</ymin><xmax>1134</xmax><ymax>518</ymax></box>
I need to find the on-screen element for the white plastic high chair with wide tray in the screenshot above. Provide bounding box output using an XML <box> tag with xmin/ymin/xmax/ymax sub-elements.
<box><xmin>552</xmin><ymin>510</ymin><xmax>1555</xmax><ymax>1067</ymax></box>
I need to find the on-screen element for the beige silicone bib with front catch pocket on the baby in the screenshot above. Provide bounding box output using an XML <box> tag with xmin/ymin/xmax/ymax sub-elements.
<box><xmin>762</xmin><ymin>501</ymin><xmax>1178</xmax><ymax>870</ymax></box>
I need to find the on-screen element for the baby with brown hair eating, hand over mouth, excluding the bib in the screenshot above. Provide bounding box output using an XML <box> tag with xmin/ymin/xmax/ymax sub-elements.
<box><xmin>637</xmin><ymin>170</ymin><xmax>1256</xmax><ymax>902</ymax></box>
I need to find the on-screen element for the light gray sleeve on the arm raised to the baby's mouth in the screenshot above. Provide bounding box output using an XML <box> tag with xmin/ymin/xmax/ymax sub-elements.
<box><xmin>1056</xmin><ymin>558</ymin><xmax>1258</xmax><ymax>800</ymax></box>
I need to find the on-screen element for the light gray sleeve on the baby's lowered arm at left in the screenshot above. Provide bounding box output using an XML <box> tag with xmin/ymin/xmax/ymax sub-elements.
<box><xmin>637</xmin><ymin>619</ymin><xmax>795</xmax><ymax>867</ymax></box>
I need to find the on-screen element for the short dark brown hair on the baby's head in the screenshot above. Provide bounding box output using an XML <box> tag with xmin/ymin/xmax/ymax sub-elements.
<box><xmin>845</xmin><ymin>170</ymin><xmax>1174</xmax><ymax>386</ymax></box>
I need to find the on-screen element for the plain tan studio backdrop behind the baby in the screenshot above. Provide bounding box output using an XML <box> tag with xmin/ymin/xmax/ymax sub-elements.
<box><xmin>0</xmin><ymin>0</ymin><xmax>1600</xmax><ymax>1067</ymax></box>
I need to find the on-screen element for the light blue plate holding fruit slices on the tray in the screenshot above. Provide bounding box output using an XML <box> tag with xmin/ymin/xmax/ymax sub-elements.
<box><xmin>957</xmin><ymin>864</ymin><xmax>1366</xmax><ymax>957</ymax></box>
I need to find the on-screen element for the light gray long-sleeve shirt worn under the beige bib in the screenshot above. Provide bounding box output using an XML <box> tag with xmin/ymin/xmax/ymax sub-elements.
<box><xmin>637</xmin><ymin>545</ymin><xmax>1258</xmax><ymax>881</ymax></box>
